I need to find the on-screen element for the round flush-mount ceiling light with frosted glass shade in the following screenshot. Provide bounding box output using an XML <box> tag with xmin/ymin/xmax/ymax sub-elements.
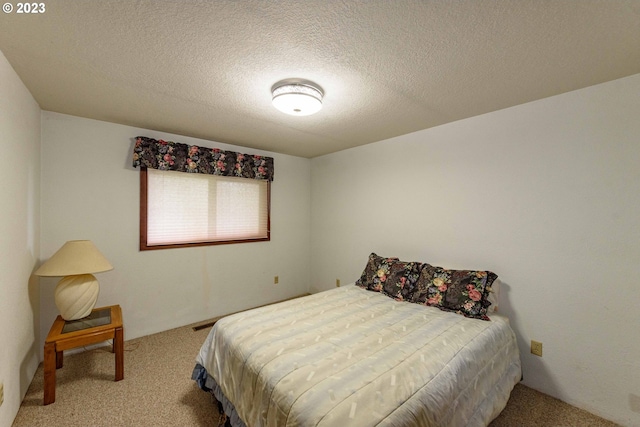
<box><xmin>271</xmin><ymin>79</ymin><xmax>324</xmax><ymax>116</ymax></box>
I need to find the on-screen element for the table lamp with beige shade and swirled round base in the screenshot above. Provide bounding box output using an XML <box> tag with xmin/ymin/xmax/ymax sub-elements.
<box><xmin>33</xmin><ymin>240</ymin><xmax>113</xmax><ymax>320</ymax></box>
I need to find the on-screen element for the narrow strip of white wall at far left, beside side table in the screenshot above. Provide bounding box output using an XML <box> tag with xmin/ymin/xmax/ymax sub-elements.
<box><xmin>0</xmin><ymin>52</ymin><xmax>40</xmax><ymax>427</ymax></box>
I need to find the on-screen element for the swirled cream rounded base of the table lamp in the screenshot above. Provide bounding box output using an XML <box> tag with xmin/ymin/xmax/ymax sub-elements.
<box><xmin>55</xmin><ymin>274</ymin><xmax>100</xmax><ymax>320</ymax></box>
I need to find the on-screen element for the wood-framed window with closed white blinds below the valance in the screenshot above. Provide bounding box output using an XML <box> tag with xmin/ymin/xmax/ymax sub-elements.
<box><xmin>140</xmin><ymin>167</ymin><xmax>271</xmax><ymax>250</ymax></box>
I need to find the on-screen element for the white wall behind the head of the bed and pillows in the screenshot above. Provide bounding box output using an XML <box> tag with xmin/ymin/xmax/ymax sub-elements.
<box><xmin>311</xmin><ymin>75</ymin><xmax>640</xmax><ymax>426</ymax></box>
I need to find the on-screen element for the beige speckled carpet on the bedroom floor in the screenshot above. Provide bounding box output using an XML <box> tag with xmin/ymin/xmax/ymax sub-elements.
<box><xmin>13</xmin><ymin>324</ymin><xmax>616</xmax><ymax>427</ymax></box>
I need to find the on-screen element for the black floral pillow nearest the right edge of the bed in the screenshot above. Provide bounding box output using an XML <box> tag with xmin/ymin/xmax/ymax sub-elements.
<box><xmin>410</xmin><ymin>264</ymin><xmax>498</xmax><ymax>320</ymax></box>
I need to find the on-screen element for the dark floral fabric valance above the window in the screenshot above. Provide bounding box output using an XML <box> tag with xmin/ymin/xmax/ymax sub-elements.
<box><xmin>133</xmin><ymin>136</ymin><xmax>273</xmax><ymax>181</ymax></box>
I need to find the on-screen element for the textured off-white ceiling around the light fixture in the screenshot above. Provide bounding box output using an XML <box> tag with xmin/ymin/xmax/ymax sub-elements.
<box><xmin>0</xmin><ymin>0</ymin><xmax>640</xmax><ymax>157</ymax></box>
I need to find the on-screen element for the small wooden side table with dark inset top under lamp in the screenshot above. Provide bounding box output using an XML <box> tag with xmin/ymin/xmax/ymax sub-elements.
<box><xmin>44</xmin><ymin>305</ymin><xmax>124</xmax><ymax>405</ymax></box>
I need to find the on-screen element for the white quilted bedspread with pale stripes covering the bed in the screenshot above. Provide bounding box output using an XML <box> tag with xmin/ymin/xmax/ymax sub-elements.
<box><xmin>196</xmin><ymin>285</ymin><xmax>521</xmax><ymax>427</ymax></box>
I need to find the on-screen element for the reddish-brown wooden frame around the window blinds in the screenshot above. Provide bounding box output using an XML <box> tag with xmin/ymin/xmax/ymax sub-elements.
<box><xmin>140</xmin><ymin>166</ymin><xmax>271</xmax><ymax>251</ymax></box>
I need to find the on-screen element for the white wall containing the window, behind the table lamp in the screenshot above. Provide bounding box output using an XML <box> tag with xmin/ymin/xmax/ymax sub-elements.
<box><xmin>41</xmin><ymin>112</ymin><xmax>311</xmax><ymax>357</ymax></box>
